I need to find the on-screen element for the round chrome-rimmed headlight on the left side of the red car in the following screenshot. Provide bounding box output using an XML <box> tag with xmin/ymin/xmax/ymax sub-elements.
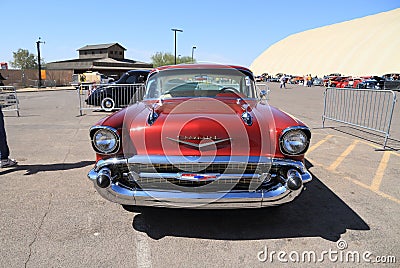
<box><xmin>93</xmin><ymin>128</ymin><xmax>119</xmax><ymax>154</ymax></box>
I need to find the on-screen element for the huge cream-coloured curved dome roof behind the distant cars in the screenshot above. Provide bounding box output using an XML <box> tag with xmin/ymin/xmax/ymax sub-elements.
<box><xmin>250</xmin><ymin>8</ymin><xmax>400</xmax><ymax>76</ymax></box>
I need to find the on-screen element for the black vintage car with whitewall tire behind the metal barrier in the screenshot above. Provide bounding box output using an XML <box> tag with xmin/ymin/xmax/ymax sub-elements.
<box><xmin>85</xmin><ymin>70</ymin><xmax>149</xmax><ymax>111</ymax></box>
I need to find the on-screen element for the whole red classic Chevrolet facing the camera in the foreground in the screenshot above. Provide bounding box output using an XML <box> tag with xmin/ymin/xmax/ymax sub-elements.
<box><xmin>88</xmin><ymin>64</ymin><xmax>312</xmax><ymax>208</ymax></box>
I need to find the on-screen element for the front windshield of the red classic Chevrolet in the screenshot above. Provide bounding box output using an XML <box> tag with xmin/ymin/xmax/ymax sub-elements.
<box><xmin>145</xmin><ymin>69</ymin><xmax>256</xmax><ymax>99</ymax></box>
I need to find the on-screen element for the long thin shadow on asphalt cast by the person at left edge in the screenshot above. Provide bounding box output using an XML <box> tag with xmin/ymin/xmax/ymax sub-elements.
<box><xmin>0</xmin><ymin>161</ymin><xmax>95</xmax><ymax>176</ymax></box>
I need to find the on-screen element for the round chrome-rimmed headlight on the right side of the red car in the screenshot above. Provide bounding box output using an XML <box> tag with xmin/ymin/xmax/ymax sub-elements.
<box><xmin>281</xmin><ymin>130</ymin><xmax>308</xmax><ymax>155</ymax></box>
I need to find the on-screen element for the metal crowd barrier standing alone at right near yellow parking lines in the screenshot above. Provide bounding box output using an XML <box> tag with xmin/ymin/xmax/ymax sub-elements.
<box><xmin>322</xmin><ymin>88</ymin><xmax>396</xmax><ymax>149</ymax></box>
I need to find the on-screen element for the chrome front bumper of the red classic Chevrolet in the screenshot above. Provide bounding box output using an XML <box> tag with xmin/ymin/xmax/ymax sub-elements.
<box><xmin>88</xmin><ymin>156</ymin><xmax>312</xmax><ymax>209</ymax></box>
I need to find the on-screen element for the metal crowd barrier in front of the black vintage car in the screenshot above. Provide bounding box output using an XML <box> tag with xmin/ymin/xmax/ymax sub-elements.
<box><xmin>76</xmin><ymin>83</ymin><xmax>145</xmax><ymax>115</ymax></box>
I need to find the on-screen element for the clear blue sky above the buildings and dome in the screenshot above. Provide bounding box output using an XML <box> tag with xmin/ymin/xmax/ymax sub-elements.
<box><xmin>0</xmin><ymin>0</ymin><xmax>400</xmax><ymax>66</ymax></box>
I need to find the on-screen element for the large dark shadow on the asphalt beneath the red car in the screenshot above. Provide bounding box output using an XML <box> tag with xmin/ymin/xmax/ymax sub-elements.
<box><xmin>132</xmin><ymin>160</ymin><xmax>370</xmax><ymax>241</ymax></box>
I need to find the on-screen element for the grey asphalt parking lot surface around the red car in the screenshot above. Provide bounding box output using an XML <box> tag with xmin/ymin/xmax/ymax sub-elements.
<box><xmin>0</xmin><ymin>83</ymin><xmax>400</xmax><ymax>267</ymax></box>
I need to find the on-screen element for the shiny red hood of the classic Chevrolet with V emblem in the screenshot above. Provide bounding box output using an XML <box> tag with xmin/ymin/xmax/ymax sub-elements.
<box><xmin>99</xmin><ymin>98</ymin><xmax>303</xmax><ymax>157</ymax></box>
